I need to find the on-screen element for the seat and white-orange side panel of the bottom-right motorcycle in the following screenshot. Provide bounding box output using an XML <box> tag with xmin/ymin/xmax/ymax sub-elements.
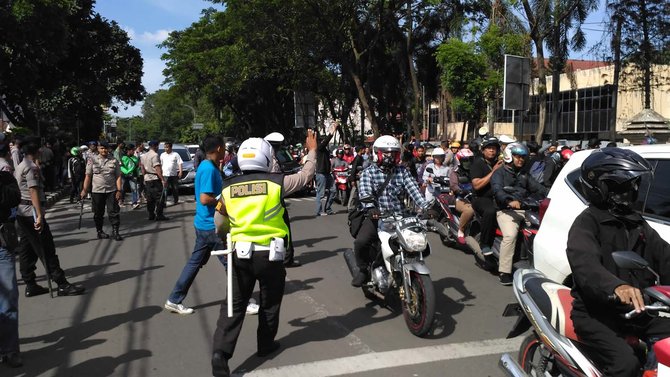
<box><xmin>525</xmin><ymin>277</ymin><xmax>579</xmax><ymax>342</ymax></box>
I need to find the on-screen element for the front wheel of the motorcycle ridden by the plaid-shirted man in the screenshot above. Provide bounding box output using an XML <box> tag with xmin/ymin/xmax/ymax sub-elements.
<box><xmin>402</xmin><ymin>271</ymin><xmax>435</xmax><ymax>337</ymax></box>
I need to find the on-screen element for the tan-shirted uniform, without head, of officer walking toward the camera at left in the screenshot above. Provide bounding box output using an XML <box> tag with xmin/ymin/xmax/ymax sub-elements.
<box><xmin>86</xmin><ymin>155</ymin><xmax>121</xmax><ymax>235</ymax></box>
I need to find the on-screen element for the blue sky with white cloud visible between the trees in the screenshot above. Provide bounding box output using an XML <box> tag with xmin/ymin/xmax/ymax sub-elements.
<box><xmin>95</xmin><ymin>0</ymin><xmax>616</xmax><ymax>117</ymax></box>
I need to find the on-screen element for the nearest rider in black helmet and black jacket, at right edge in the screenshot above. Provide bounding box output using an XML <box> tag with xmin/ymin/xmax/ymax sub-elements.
<box><xmin>567</xmin><ymin>148</ymin><xmax>670</xmax><ymax>377</ymax></box>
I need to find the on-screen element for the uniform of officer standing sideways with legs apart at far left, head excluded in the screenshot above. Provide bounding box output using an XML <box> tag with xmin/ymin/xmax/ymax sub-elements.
<box><xmin>14</xmin><ymin>157</ymin><xmax>67</xmax><ymax>296</ymax></box>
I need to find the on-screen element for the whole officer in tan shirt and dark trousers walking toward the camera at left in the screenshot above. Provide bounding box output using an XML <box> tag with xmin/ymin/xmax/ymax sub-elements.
<box><xmin>81</xmin><ymin>141</ymin><xmax>123</xmax><ymax>241</ymax></box>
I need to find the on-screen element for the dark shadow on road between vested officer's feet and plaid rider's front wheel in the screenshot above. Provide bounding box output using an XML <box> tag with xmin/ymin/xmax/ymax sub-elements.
<box><xmin>234</xmin><ymin>302</ymin><xmax>398</xmax><ymax>373</ymax></box>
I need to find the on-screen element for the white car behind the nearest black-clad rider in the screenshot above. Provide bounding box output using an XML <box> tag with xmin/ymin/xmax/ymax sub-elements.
<box><xmin>533</xmin><ymin>144</ymin><xmax>670</xmax><ymax>286</ymax></box>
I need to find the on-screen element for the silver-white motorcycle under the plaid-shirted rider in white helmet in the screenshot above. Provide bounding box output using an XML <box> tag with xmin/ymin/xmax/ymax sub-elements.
<box><xmin>344</xmin><ymin>210</ymin><xmax>435</xmax><ymax>337</ymax></box>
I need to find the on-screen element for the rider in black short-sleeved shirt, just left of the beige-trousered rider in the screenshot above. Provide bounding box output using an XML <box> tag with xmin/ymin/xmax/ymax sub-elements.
<box><xmin>470</xmin><ymin>137</ymin><xmax>503</xmax><ymax>255</ymax></box>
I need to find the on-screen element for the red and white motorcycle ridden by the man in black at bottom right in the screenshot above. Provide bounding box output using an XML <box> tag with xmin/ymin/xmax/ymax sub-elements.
<box><xmin>499</xmin><ymin>251</ymin><xmax>670</xmax><ymax>377</ymax></box>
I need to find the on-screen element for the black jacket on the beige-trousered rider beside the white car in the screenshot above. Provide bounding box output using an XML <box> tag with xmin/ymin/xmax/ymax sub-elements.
<box><xmin>491</xmin><ymin>165</ymin><xmax>547</xmax><ymax>209</ymax></box>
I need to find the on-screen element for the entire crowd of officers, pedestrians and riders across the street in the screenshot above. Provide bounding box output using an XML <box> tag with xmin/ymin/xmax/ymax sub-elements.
<box><xmin>0</xmin><ymin>127</ymin><xmax>670</xmax><ymax>376</ymax></box>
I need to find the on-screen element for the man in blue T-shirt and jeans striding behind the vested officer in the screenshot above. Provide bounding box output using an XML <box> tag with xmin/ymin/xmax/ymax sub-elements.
<box><xmin>165</xmin><ymin>135</ymin><xmax>226</xmax><ymax>314</ymax></box>
